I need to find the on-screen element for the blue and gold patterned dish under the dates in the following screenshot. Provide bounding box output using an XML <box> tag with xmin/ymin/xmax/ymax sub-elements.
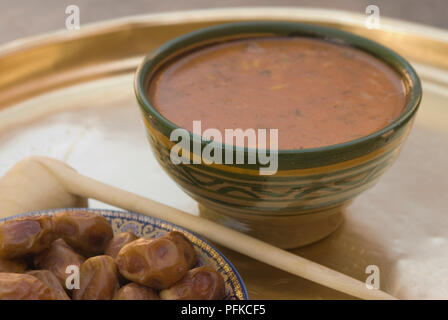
<box><xmin>0</xmin><ymin>208</ymin><xmax>249</xmax><ymax>300</ymax></box>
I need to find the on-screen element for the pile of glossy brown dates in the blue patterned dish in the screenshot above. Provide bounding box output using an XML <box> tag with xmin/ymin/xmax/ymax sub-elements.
<box><xmin>0</xmin><ymin>210</ymin><xmax>225</xmax><ymax>300</ymax></box>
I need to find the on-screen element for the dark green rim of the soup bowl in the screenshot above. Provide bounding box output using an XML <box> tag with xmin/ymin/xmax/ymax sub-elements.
<box><xmin>134</xmin><ymin>21</ymin><xmax>422</xmax><ymax>156</ymax></box>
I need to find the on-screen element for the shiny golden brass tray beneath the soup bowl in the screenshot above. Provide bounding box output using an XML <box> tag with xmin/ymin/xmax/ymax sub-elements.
<box><xmin>0</xmin><ymin>8</ymin><xmax>448</xmax><ymax>299</ymax></box>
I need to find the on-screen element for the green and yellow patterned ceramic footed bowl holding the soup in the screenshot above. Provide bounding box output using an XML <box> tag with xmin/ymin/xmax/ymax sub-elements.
<box><xmin>135</xmin><ymin>22</ymin><xmax>422</xmax><ymax>248</ymax></box>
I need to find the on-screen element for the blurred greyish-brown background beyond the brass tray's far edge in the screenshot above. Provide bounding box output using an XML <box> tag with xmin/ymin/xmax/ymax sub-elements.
<box><xmin>0</xmin><ymin>0</ymin><xmax>448</xmax><ymax>44</ymax></box>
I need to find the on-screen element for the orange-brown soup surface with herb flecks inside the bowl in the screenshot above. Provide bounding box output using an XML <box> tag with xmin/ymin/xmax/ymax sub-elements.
<box><xmin>148</xmin><ymin>37</ymin><xmax>405</xmax><ymax>149</ymax></box>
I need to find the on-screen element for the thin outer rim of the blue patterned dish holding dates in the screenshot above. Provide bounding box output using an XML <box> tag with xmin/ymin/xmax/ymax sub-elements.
<box><xmin>0</xmin><ymin>208</ymin><xmax>249</xmax><ymax>300</ymax></box>
